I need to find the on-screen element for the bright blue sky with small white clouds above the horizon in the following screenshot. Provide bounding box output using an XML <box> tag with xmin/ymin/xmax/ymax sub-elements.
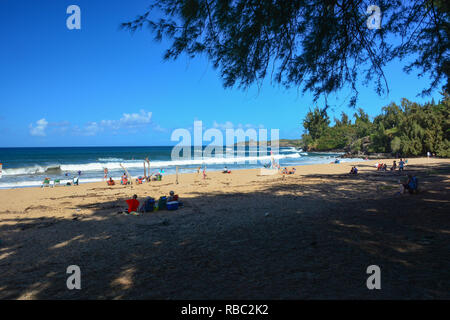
<box><xmin>0</xmin><ymin>0</ymin><xmax>440</xmax><ymax>147</ymax></box>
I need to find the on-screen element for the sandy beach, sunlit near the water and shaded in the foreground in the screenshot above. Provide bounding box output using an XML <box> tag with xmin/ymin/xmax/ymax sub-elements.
<box><xmin>0</xmin><ymin>158</ymin><xmax>450</xmax><ymax>299</ymax></box>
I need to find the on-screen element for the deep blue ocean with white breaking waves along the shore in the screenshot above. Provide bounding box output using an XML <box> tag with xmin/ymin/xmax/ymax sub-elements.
<box><xmin>0</xmin><ymin>146</ymin><xmax>362</xmax><ymax>189</ymax></box>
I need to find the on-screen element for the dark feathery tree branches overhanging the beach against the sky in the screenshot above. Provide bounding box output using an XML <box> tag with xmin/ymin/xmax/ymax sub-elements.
<box><xmin>122</xmin><ymin>0</ymin><xmax>450</xmax><ymax>105</ymax></box>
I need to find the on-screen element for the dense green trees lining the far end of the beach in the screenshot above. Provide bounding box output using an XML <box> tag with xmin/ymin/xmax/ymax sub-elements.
<box><xmin>301</xmin><ymin>94</ymin><xmax>450</xmax><ymax>157</ymax></box>
